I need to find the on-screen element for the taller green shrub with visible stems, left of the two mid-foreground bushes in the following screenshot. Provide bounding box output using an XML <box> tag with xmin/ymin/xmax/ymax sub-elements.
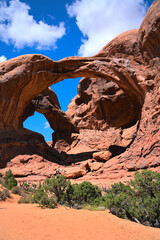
<box><xmin>43</xmin><ymin>175</ymin><xmax>73</xmax><ymax>204</ymax></box>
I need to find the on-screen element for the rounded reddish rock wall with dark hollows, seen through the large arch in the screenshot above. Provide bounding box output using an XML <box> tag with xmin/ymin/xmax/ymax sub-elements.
<box><xmin>67</xmin><ymin>78</ymin><xmax>139</xmax><ymax>130</ymax></box>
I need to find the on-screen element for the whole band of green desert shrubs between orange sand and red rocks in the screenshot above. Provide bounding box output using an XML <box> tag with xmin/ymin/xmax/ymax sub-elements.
<box><xmin>0</xmin><ymin>170</ymin><xmax>160</xmax><ymax>228</ymax></box>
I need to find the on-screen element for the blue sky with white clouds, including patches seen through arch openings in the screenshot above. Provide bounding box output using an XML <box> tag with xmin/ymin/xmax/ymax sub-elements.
<box><xmin>0</xmin><ymin>0</ymin><xmax>153</xmax><ymax>141</ymax></box>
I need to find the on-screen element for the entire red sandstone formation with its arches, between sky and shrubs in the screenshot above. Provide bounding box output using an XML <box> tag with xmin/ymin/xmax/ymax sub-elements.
<box><xmin>0</xmin><ymin>0</ymin><xmax>160</xmax><ymax>182</ymax></box>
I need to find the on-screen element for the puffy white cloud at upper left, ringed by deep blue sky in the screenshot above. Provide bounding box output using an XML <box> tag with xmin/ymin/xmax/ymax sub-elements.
<box><xmin>0</xmin><ymin>0</ymin><xmax>65</xmax><ymax>49</ymax></box>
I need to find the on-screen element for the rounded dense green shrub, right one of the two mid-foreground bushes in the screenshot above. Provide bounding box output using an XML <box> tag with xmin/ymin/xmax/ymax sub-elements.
<box><xmin>72</xmin><ymin>181</ymin><xmax>101</xmax><ymax>204</ymax></box>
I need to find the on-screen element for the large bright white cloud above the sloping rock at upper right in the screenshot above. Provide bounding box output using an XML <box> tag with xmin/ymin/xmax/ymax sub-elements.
<box><xmin>66</xmin><ymin>0</ymin><xmax>146</xmax><ymax>56</ymax></box>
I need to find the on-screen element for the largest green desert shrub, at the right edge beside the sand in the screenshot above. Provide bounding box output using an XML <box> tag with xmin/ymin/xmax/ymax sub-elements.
<box><xmin>104</xmin><ymin>170</ymin><xmax>160</xmax><ymax>227</ymax></box>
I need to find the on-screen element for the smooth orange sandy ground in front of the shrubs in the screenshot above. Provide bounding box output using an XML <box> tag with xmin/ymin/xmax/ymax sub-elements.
<box><xmin>0</xmin><ymin>196</ymin><xmax>160</xmax><ymax>240</ymax></box>
